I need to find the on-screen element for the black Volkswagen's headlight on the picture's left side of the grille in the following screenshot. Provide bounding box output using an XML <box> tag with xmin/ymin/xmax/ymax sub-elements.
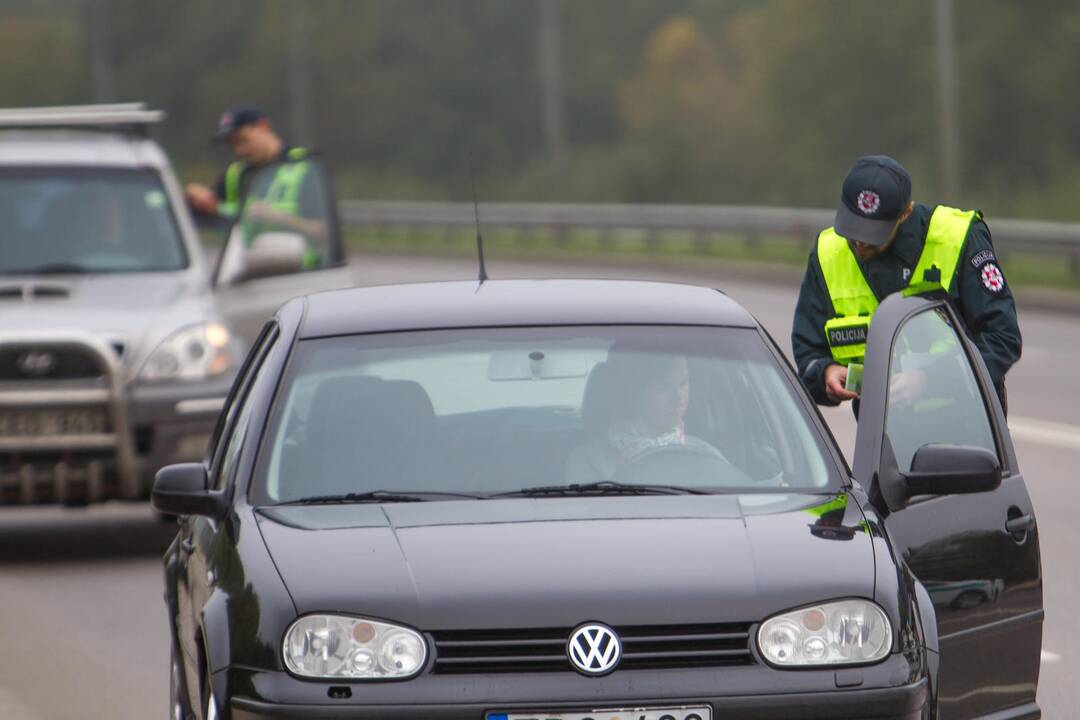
<box><xmin>282</xmin><ymin>615</ymin><xmax>428</xmax><ymax>680</ymax></box>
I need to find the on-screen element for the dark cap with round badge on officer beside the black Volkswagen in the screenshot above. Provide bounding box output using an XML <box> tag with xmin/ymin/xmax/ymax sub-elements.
<box><xmin>834</xmin><ymin>155</ymin><xmax>912</xmax><ymax>245</ymax></box>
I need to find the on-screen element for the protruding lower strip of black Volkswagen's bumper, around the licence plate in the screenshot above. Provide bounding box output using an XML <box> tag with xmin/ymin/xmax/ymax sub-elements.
<box><xmin>231</xmin><ymin>680</ymin><xmax>929</xmax><ymax>720</ymax></box>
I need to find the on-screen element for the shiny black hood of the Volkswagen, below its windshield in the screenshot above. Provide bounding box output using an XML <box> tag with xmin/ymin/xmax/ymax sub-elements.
<box><xmin>259</xmin><ymin>494</ymin><xmax>874</xmax><ymax>630</ymax></box>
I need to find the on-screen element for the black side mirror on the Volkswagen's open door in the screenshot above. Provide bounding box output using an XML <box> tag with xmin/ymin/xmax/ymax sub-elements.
<box><xmin>903</xmin><ymin>445</ymin><xmax>1001</xmax><ymax>497</ymax></box>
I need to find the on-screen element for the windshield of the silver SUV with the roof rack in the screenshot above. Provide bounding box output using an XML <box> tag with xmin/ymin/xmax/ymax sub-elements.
<box><xmin>0</xmin><ymin>168</ymin><xmax>187</xmax><ymax>274</ymax></box>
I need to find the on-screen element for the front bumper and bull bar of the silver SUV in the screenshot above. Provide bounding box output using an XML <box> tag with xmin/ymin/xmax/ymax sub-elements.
<box><xmin>0</xmin><ymin>334</ymin><xmax>232</xmax><ymax>505</ymax></box>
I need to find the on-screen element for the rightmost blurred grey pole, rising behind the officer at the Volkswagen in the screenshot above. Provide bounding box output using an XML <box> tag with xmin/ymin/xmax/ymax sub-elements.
<box><xmin>934</xmin><ymin>0</ymin><xmax>960</xmax><ymax>197</ymax></box>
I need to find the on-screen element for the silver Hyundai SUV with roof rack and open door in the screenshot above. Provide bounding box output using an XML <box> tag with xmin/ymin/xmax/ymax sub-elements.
<box><xmin>0</xmin><ymin>104</ymin><xmax>352</xmax><ymax>504</ymax></box>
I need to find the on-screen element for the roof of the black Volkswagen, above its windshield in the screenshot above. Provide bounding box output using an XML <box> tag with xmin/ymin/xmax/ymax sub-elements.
<box><xmin>299</xmin><ymin>280</ymin><xmax>757</xmax><ymax>339</ymax></box>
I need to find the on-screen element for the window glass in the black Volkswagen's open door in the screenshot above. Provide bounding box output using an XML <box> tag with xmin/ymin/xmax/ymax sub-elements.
<box><xmin>886</xmin><ymin>308</ymin><xmax>1000</xmax><ymax>472</ymax></box>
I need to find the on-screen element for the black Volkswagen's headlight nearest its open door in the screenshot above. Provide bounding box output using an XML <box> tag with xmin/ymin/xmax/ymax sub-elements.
<box><xmin>757</xmin><ymin>600</ymin><xmax>892</xmax><ymax>667</ymax></box>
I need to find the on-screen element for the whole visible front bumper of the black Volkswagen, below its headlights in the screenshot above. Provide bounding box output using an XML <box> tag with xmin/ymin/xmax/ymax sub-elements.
<box><xmin>219</xmin><ymin>655</ymin><xmax>930</xmax><ymax>720</ymax></box>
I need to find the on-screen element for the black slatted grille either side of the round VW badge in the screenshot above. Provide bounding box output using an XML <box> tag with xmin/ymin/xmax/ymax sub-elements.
<box><xmin>431</xmin><ymin>623</ymin><xmax>754</xmax><ymax>675</ymax></box>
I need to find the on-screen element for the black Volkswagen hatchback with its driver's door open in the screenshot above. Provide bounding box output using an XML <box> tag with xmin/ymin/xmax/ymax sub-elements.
<box><xmin>153</xmin><ymin>281</ymin><xmax>1043</xmax><ymax>720</ymax></box>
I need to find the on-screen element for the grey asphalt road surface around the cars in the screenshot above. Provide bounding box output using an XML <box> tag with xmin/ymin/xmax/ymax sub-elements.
<box><xmin>0</xmin><ymin>258</ymin><xmax>1080</xmax><ymax>720</ymax></box>
